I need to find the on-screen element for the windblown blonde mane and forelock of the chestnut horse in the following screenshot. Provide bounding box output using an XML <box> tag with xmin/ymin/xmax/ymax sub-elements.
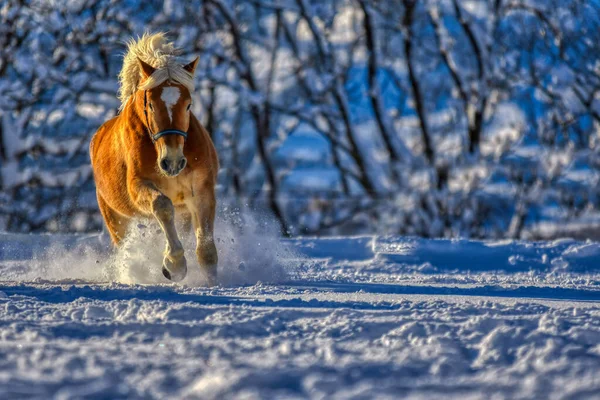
<box><xmin>119</xmin><ymin>32</ymin><xmax>194</xmax><ymax>109</ymax></box>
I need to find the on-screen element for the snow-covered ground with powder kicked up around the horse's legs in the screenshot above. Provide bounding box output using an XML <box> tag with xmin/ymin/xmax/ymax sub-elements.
<box><xmin>0</xmin><ymin>220</ymin><xmax>600</xmax><ymax>399</ymax></box>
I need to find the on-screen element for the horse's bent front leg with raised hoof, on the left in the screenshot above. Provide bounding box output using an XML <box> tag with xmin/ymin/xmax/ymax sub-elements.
<box><xmin>130</xmin><ymin>178</ymin><xmax>187</xmax><ymax>282</ymax></box>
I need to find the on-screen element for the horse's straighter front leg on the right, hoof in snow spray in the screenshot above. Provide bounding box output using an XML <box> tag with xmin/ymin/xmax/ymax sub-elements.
<box><xmin>188</xmin><ymin>186</ymin><xmax>218</xmax><ymax>286</ymax></box>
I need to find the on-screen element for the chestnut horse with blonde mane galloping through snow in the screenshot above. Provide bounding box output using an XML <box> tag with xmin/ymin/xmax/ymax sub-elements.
<box><xmin>90</xmin><ymin>33</ymin><xmax>219</xmax><ymax>285</ymax></box>
